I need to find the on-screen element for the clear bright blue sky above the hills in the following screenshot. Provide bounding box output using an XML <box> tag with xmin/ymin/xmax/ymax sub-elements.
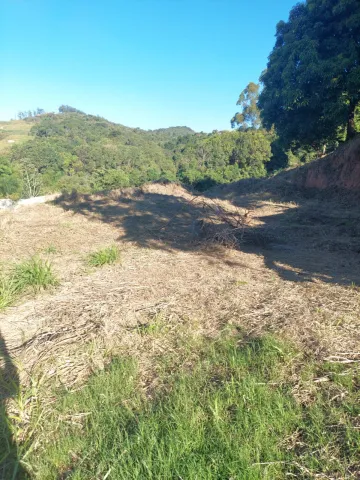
<box><xmin>0</xmin><ymin>0</ymin><xmax>296</xmax><ymax>131</ymax></box>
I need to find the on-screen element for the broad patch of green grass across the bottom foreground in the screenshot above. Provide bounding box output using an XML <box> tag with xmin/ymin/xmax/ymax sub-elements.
<box><xmin>26</xmin><ymin>337</ymin><xmax>360</xmax><ymax>480</ymax></box>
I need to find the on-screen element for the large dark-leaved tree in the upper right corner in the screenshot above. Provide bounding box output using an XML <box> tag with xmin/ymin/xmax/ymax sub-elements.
<box><xmin>259</xmin><ymin>0</ymin><xmax>360</xmax><ymax>146</ymax></box>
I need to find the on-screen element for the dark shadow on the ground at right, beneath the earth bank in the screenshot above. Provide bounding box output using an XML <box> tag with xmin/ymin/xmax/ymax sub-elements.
<box><xmin>207</xmin><ymin>176</ymin><xmax>360</xmax><ymax>285</ymax></box>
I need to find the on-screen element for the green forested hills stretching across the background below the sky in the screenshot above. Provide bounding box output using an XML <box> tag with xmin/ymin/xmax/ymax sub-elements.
<box><xmin>0</xmin><ymin>107</ymin><xmax>272</xmax><ymax>198</ymax></box>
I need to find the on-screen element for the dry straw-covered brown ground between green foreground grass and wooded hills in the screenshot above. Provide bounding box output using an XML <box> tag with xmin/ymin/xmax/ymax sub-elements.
<box><xmin>0</xmin><ymin>183</ymin><xmax>360</xmax><ymax>385</ymax></box>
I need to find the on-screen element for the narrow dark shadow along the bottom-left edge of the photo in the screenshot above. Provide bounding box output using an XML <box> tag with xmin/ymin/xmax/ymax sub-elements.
<box><xmin>0</xmin><ymin>336</ymin><xmax>28</xmax><ymax>480</ymax></box>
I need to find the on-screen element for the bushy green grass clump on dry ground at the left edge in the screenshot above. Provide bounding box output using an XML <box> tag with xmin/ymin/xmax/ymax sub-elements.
<box><xmin>0</xmin><ymin>257</ymin><xmax>58</xmax><ymax>310</ymax></box>
